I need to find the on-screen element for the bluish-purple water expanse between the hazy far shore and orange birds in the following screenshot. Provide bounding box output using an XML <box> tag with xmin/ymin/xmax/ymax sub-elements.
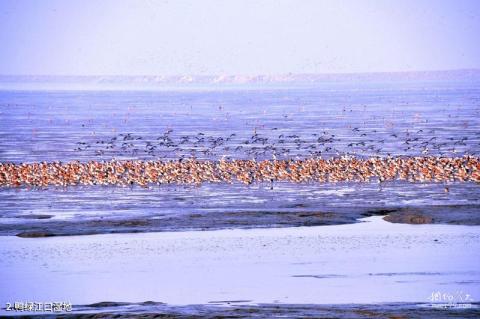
<box><xmin>0</xmin><ymin>82</ymin><xmax>480</xmax><ymax>162</ymax></box>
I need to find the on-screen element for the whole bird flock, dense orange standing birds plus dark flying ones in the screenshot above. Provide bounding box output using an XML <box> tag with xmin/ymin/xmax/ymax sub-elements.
<box><xmin>0</xmin><ymin>121</ymin><xmax>480</xmax><ymax>189</ymax></box>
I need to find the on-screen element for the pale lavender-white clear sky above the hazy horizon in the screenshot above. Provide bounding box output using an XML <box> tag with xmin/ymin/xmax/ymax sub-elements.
<box><xmin>0</xmin><ymin>0</ymin><xmax>480</xmax><ymax>75</ymax></box>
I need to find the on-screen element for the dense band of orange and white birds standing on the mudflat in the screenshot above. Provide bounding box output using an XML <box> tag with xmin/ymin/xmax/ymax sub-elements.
<box><xmin>0</xmin><ymin>156</ymin><xmax>480</xmax><ymax>187</ymax></box>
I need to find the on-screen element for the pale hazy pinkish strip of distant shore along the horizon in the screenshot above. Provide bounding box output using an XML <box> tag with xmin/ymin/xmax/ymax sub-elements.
<box><xmin>0</xmin><ymin>69</ymin><xmax>480</xmax><ymax>89</ymax></box>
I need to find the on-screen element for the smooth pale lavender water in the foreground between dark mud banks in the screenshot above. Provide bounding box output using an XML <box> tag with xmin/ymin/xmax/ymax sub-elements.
<box><xmin>0</xmin><ymin>217</ymin><xmax>480</xmax><ymax>312</ymax></box>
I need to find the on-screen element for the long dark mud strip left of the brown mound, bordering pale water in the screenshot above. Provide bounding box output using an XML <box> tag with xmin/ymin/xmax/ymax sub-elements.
<box><xmin>5</xmin><ymin>211</ymin><xmax>361</xmax><ymax>238</ymax></box>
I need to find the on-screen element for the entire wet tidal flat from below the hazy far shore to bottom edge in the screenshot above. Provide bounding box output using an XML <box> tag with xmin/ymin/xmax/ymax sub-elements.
<box><xmin>0</xmin><ymin>81</ymin><xmax>480</xmax><ymax>318</ymax></box>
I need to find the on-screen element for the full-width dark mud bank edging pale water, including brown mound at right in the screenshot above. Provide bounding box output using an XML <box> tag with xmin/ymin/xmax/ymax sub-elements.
<box><xmin>0</xmin><ymin>205</ymin><xmax>480</xmax><ymax>238</ymax></box>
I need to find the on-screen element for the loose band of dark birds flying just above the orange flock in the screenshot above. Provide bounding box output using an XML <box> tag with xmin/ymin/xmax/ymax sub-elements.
<box><xmin>74</xmin><ymin>127</ymin><xmax>480</xmax><ymax>160</ymax></box>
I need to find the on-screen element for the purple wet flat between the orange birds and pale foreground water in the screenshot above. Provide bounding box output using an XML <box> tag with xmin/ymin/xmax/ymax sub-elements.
<box><xmin>0</xmin><ymin>182</ymin><xmax>480</xmax><ymax>235</ymax></box>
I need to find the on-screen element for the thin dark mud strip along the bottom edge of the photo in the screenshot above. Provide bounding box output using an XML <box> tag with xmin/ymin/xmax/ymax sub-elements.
<box><xmin>4</xmin><ymin>302</ymin><xmax>480</xmax><ymax>319</ymax></box>
